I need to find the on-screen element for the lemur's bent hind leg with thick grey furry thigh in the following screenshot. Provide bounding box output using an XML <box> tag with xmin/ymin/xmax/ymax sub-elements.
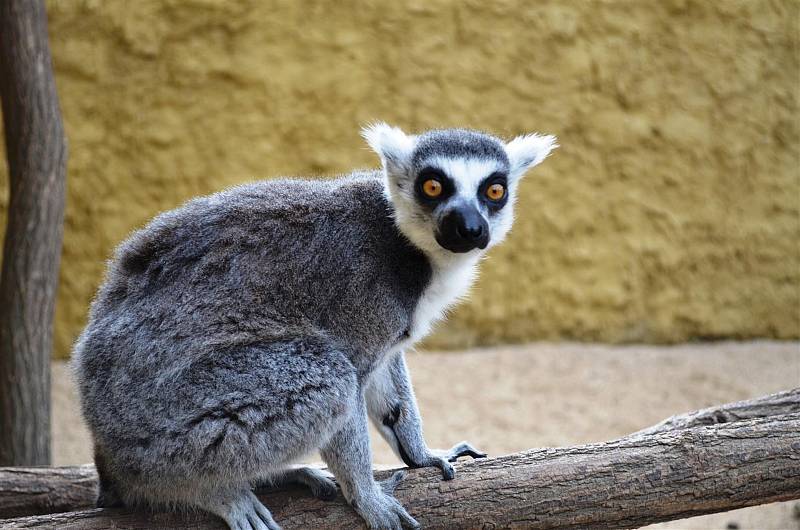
<box><xmin>107</xmin><ymin>337</ymin><xmax>361</xmax><ymax>530</ymax></box>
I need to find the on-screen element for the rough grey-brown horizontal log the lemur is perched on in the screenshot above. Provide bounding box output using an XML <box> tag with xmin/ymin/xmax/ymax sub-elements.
<box><xmin>0</xmin><ymin>389</ymin><xmax>800</xmax><ymax>530</ymax></box>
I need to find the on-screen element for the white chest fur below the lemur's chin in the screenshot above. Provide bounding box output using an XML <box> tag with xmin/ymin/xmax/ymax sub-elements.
<box><xmin>397</xmin><ymin>255</ymin><xmax>480</xmax><ymax>350</ymax></box>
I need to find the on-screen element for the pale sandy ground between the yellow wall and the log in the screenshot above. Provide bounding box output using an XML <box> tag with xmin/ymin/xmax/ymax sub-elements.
<box><xmin>53</xmin><ymin>342</ymin><xmax>800</xmax><ymax>530</ymax></box>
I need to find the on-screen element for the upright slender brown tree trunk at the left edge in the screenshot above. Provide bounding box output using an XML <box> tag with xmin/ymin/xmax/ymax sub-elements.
<box><xmin>0</xmin><ymin>0</ymin><xmax>67</xmax><ymax>466</ymax></box>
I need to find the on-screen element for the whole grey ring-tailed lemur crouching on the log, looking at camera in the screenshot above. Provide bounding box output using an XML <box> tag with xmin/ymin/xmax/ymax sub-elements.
<box><xmin>73</xmin><ymin>124</ymin><xmax>555</xmax><ymax>530</ymax></box>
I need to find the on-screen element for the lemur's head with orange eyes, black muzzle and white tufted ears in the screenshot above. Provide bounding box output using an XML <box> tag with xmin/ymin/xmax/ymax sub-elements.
<box><xmin>362</xmin><ymin>123</ymin><xmax>557</xmax><ymax>256</ymax></box>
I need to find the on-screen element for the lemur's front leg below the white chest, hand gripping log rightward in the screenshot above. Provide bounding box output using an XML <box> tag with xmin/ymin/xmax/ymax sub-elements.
<box><xmin>366</xmin><ymin>352</ymin><xmax>486</xmax><ymax>480</ymax></box>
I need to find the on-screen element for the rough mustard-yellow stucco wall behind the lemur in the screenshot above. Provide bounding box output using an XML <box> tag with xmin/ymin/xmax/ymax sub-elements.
<box><xmin>0</xmin><ymin>0</ymin><xmax>800</xmax><ymax>356</ymax></box>
